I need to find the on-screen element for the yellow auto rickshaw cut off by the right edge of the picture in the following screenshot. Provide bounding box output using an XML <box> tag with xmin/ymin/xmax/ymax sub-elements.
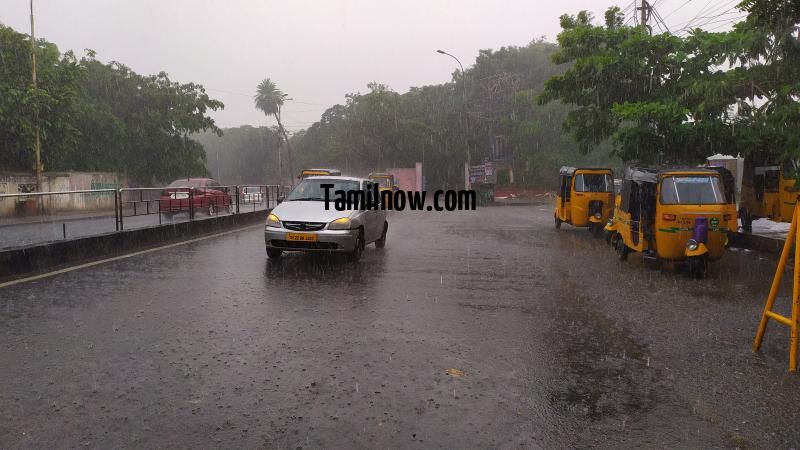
<box><xmin>739</xmin><ymin>158</ymin><xmax>798</xmax><ymax>232</ymax></box>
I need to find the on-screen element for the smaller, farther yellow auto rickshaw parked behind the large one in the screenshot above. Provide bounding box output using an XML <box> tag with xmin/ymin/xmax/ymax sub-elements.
<box><xmin>553</xmin><ymin>167</ymin><xmax>614</xmax><ymax>237</ymax></box>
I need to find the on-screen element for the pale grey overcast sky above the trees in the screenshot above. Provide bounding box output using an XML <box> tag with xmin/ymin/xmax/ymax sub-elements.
<box><xmin>0</xmin><ymin>0</ymin><xmax>736</xmax><ymax>130</ymax></box>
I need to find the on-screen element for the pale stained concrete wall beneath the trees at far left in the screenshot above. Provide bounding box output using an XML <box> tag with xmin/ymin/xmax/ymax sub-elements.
<box><xmin>0</xmin><ymin>172</ymin><xmax>128</xmax><ymax>217</ymax></box>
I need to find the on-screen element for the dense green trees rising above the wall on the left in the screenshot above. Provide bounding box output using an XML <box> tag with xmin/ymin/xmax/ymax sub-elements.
<box><xmin>0</xmin><ymin>25</ymin><xmax>223</xmax><ymax>184</ymax></box>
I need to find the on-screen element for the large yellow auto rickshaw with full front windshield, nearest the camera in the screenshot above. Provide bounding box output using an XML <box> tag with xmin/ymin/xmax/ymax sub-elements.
<box><xmin>606</xmin><ymin>167</ymin><xmax>737</xmax><ymax>276</ymax></box>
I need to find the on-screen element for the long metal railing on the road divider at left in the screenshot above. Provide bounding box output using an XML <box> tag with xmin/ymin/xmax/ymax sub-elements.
<box><xmin>0</xmin><ymin>185</ymin><xmax>282</xmax><ymax>248</ymax></box>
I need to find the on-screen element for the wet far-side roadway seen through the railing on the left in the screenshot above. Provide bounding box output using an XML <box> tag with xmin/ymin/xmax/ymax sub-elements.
<box><xmin>0</xmin><ymin>202</ymin><xmax>267</xmax><ymax>249</ymax></box>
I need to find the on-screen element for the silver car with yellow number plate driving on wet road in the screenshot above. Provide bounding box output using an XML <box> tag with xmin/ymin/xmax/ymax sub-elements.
<box><xmin>264</xmin><ymin>176</ymin><xmax>389</xmax><ymax>261</ymax></box>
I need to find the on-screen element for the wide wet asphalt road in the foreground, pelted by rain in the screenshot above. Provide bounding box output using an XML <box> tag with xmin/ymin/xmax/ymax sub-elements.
<box><xmin>0</xmin><ymin>205</ymin><xmax>800</xmax><ymax>449</ymax></box>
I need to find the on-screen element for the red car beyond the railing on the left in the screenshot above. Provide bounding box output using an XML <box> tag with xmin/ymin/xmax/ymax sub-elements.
<box><xmin>158</xmin><ymin>178</ymin><xmax>233</xmax><ymax>219</ymax></box>
